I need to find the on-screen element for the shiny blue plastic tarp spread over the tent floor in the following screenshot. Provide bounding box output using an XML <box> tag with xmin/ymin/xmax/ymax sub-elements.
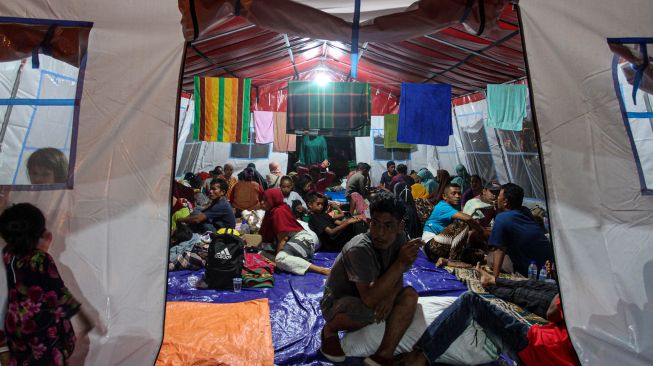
<box><xmin>167</xmin><ymin>253</ymin><xmax>467</xmax><ymax>365</ymax></box>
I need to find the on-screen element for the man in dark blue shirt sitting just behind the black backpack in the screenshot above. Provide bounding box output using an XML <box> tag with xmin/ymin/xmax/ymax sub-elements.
<box><xmin>177</xmin><ymin>178</ymin><xmax>236</xmax><ymax>233</ymax></box>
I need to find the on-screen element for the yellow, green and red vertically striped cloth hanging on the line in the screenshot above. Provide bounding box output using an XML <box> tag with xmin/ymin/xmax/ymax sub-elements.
<box><xmin>193</xmin><ymin>76</ymin><xmax>252</xmax><ymax>144</ymax></box>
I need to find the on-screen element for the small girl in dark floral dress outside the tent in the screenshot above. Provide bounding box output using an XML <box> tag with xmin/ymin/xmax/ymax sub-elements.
<box><xmin>0</xmin><ymin>203</ymin><xmax>80</xmax><ymax>366</ymax></box>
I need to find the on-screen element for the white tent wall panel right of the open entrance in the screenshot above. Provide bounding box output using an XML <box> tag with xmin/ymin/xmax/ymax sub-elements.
<box><xmin>520</xmin><ymin>0</ymin><xmax>653</xmax><ymax>365</ymax></box>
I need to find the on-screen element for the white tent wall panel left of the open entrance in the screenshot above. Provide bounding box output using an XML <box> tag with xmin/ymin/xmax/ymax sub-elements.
<box><xmin>0</xmin><ymin>0</ymin><xmax>183</xmax><ymax>365</ymax></box>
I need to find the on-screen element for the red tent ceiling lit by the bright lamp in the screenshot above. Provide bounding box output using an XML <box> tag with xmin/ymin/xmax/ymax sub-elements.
<box><xmin>182</xmin><ymin>5</ymin><xmax>526</xmax><ymax>100</ymax></box>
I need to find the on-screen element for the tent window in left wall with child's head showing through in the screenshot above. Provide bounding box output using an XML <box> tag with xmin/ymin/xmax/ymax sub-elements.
<box><xmin>0</xmin><ymin>18</ymin><xmax>92</xmax><ymax>189</ymax></box>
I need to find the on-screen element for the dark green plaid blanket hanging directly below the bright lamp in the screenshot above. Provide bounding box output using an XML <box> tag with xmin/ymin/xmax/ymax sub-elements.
<box><xmin>286</xmin><ymin>81</ymin><xmax>372</xmax><ymax>137</ymax></box>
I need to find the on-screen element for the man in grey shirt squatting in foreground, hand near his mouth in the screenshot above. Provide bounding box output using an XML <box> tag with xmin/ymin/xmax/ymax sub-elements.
<box><xmin>320</xmin><ymin>192</ymin><xmax>421</xmax><ymax>365</ymax></box>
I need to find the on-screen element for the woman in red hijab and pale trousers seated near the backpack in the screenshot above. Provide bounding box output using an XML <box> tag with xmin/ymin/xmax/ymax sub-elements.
<box><xmin>259</xmin><ymin>188</ymin><xmax>330</xmax><ymax>275</ymax></box>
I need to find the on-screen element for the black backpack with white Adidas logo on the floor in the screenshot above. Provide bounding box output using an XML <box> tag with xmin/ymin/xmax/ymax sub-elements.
<box><xmin>204</xmin><ymin>228</ymin><xmax>245</xmax><ymax>290</ymax></box>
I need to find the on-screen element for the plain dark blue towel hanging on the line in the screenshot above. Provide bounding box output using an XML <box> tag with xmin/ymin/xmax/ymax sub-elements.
<box><xmin>397</xmin><ymin>83</ymin><xmax>453</xmax><ymax>146</ymax></box>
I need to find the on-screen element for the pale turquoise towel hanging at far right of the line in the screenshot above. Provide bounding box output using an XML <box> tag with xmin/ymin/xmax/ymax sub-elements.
<box><xmin>487</xmin><ymin>84</ymin><xmax>527</xmax><ymax>131</ymax></box>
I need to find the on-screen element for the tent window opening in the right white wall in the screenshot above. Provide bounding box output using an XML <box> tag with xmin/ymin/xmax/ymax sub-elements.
<box><xmin>608</xmin><ymin>38</ymin><xmax>653</xmax><ymax>194</ymax></box>
